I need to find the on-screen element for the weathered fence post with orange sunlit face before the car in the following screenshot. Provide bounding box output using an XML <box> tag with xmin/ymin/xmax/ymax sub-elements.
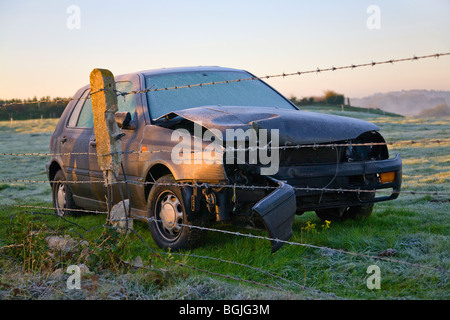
<box><xmin>90</xmin><ymin>69</ymin><xmax>122</xmax><ymax>220</ymax></box>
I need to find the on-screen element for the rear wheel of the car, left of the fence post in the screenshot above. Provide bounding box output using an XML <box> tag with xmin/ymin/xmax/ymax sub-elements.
<box><xmin>51</xmin><ymin>170</ymin><xmax>77</xmax><ymax>217</ymax></box>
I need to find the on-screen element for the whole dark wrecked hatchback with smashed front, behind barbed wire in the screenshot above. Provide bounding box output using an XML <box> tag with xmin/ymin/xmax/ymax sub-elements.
<box><xmin>47</xmin><ymin>67</ymin><xmax>402</xmax><ymax>251</ymax></box>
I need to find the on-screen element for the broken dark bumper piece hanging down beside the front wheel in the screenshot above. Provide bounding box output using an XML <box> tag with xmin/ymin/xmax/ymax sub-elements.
<box><xmin>252</xmin><ymin>178</ymin><xmax>297</xmax><ymax>253</ymax></box>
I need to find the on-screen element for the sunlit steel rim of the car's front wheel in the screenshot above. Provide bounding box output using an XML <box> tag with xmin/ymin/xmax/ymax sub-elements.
<box><xmin>155</xmin><ymin>191</ymin><xmax>184</xmax><ymax>242</ymax></box>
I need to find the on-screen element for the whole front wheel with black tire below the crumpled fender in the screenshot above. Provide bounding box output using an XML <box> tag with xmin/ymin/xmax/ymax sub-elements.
<box><xmin>147</xmin><ymin>175</ymin><xmax>206</xmax><ymax>250</ymax></box>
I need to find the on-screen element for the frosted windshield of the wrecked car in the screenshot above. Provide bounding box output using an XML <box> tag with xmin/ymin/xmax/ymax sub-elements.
<box><xmin>145</xmin><ymin>70</ymin><xmax>295</xmax><ymax>119</ymax></box>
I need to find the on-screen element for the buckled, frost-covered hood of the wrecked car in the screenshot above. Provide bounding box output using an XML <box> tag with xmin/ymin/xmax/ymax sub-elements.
<box><xmin>161</xmin><ymin>106</ymin><xmax>379</xmax><ymax>145</ymax></box>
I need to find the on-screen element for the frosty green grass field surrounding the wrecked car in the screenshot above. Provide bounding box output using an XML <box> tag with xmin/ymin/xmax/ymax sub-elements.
<box><xmin>0</xmin><ymin>107</ymin><xmax>450</xmax><ymax>300</ymax></box>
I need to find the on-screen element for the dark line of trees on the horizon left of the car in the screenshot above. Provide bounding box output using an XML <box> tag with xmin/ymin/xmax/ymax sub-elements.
<box><xmin>0</xmin><ymin>96</ymin><xmax>70</xmax><ymax>120</ymax></box>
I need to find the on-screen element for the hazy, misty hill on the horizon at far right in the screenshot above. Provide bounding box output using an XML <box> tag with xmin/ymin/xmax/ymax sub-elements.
<box><xmin>350</xmin><ymin>90</ymin><xmax>450</xmax><ymax>116</ymax></box>
